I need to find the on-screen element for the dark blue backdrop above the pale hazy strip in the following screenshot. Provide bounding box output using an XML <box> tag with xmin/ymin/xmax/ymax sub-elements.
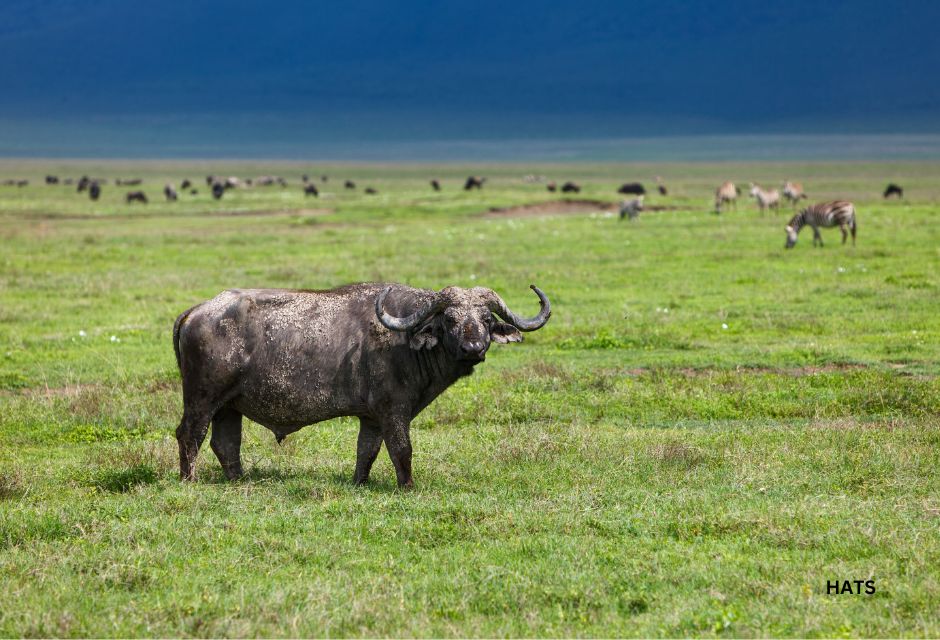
<box><xmin>0</xmin><ymin>0</ymin><xmax>940</xmax><ymax>154</ymax></box>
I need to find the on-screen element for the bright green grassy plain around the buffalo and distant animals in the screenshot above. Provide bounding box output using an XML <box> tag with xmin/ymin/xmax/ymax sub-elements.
<box><xmin>0</xmin><ymin>161</ymin><xmax>940</xmax><ymax>636</ymax></box>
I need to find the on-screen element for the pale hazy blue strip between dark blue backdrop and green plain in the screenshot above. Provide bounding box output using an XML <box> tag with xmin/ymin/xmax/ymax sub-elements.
<box><xmin>0</xmin><ymin>132</ymin><xmax>940</xmax><ymax>164</ymax></box>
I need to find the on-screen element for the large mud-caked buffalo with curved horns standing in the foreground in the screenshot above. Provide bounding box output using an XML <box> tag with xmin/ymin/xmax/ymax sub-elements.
<box><xmin>173</xmin><ymin>283</ymin><xmax>551</xmax><ymax>487</ymax></box>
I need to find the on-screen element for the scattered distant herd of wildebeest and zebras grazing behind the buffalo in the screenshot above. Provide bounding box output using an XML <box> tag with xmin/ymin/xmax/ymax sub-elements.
<box><xmin>0</xmin><ymin>175</ymin><xmax>904</xmax><ymax>248</ymax></box>
